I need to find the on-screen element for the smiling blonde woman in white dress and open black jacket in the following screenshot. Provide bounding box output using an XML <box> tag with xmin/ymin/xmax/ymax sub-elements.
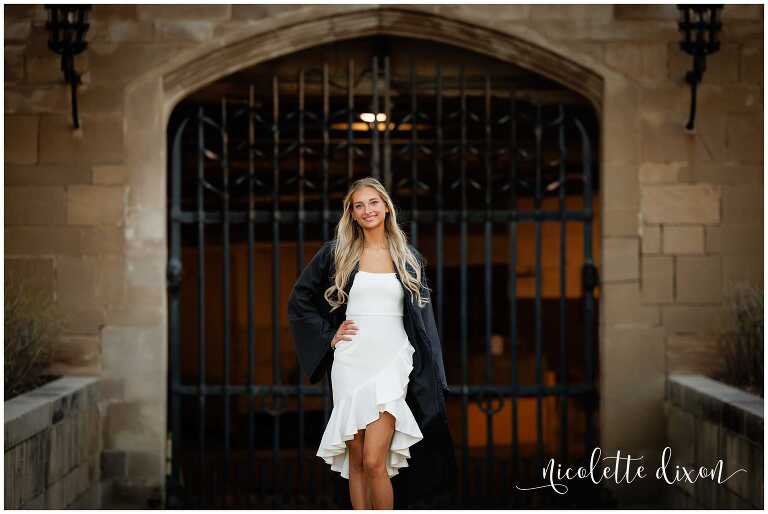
<box><xmin>288</xmin><ymin>177</ymin><xmax>455</xmax><ymax>509</ymax></box>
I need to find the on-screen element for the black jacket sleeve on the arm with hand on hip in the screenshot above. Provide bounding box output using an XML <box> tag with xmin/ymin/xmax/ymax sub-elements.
<box><xmin>288</xmin><ymin>243</ymin><xmax>336</xmax><ymax>384</ymax></box>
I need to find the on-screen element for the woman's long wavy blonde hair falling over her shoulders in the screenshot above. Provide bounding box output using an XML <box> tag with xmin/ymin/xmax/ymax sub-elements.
<box><xmin>323</xmin><ymin>177</ymin><xmax>429</xmax><ymax>311</ymax></box>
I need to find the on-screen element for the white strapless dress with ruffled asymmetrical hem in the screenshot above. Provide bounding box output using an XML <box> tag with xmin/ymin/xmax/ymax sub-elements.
<box><xmin>317</xmin><ymin>271</ymin><xmax>424</xmax><ymax>479</ymax></box>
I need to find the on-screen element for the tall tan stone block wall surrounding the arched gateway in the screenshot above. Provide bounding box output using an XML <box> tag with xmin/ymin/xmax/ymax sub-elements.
<box><xmin>4</xmin><ymin>5</ymin><xmax>763</xmax><ymax>500</ymax></box>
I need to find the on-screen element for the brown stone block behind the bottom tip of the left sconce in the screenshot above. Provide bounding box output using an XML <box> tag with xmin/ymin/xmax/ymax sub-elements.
<box><xmin>40</xmin><ymin>114</ymin><xmax>123</xmax><ymax>165</ymax></box>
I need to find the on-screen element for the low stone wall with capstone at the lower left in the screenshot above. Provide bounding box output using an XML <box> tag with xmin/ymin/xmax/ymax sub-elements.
<box><xmin>4</xmin><ymin>377</ymin><xmax>101</xmax><ymax>509</ymax></box>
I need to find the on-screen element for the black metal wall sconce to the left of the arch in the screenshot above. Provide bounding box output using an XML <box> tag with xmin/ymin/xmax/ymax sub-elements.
<box><xmin>45</xmin><ymin>4</ymin><xmax>91</xmax><ymax>128</ymax></box>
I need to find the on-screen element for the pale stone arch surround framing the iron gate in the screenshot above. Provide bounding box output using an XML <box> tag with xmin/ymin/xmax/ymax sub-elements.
<box><xmin>118</xmin><ymin>6</ymin><xmax>643</xmax><ymax>496</ymax></box>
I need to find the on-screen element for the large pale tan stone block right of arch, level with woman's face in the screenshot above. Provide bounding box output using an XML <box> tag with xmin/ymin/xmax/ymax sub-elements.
<box><xmin>640</xmin><ymin>184</ymin><xmax>721</xmax><ymax>224</ymax></box>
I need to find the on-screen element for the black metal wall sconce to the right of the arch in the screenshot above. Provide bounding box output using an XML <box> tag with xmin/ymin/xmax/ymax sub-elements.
<box><xmin>677</xmin><ymin>4</ymin><xmax>723</xmax><ymax>131</ymax></box>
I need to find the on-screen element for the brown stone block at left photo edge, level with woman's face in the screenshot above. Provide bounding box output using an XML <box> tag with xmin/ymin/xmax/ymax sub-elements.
<box><xmin>4</xmin><ymin>186</ymin><xmax>67</xmax><ymax>225</ymax></box>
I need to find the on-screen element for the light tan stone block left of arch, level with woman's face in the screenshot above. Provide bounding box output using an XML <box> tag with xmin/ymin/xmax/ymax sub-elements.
<box><xmin>67</xmin><ymin>186</ymin><xmax>125</xmax><ymax>226</ymax></box>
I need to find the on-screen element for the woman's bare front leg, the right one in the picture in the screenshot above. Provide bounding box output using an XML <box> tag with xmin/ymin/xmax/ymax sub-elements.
<box><xmin>363</xmin><ymin>411</ymin><xmax>395</xmax><ymax>510</ymax></box>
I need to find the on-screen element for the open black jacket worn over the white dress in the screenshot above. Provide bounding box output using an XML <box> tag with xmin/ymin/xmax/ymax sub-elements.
<box><xmin>288</xmin><ymin>240</ymin><xmax>456</xmax><ymax>508</ymax></box>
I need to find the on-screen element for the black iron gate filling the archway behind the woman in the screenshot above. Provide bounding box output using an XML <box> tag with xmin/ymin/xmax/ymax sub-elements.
<box><xmin>167</xmin><ymin>54</ymin><xmax>598</xmax><ymax>508</ymax></box>
